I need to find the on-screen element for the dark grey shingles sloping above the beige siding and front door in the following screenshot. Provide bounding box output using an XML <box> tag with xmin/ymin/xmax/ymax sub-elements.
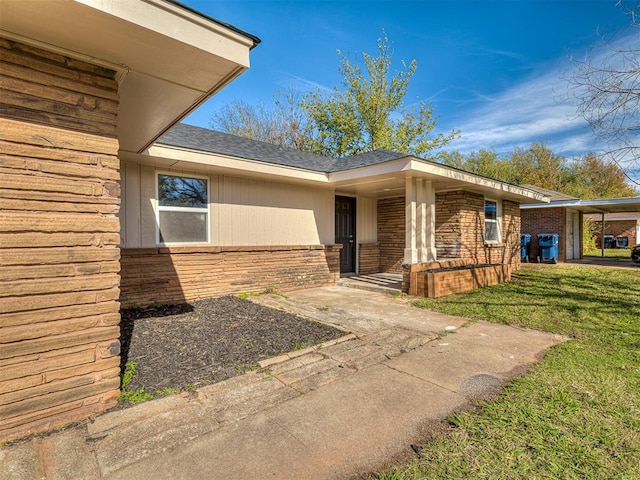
<box><xmin>157</xmin><ymin>123</ymin><xmax>407</xmax><ymax>173</ymax></box>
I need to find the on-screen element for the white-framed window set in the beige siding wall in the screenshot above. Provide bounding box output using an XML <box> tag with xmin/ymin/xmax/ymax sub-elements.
<box><xmin>157</xmin><ymin>174</ymin><xmax>209</xmax><ymax>243</ymax></box>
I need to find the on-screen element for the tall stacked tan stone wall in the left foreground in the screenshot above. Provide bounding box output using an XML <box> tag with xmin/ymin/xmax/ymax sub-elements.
<box><xmin>0</xmin><ymin>38</ymin><xmax>120</xmax><ymax>443</ymax></box>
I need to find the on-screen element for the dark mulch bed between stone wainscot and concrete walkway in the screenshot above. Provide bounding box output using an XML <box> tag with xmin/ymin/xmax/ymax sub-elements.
<box><xmin>120</xmin><ymin>296</ymin><xmax>345</xmax><ymax>400</ymax></box>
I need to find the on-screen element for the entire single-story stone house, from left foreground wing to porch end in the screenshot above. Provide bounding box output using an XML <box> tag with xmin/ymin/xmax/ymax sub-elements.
<box><xmin>0</xmin><ymin>0</ymin><xmax>546</xmax><ymax>442</ymax></box>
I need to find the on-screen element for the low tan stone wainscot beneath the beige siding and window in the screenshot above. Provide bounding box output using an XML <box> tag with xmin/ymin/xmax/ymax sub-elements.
<box><xmin>120</xmin><ymin>245</ymin><xmax>340</xmax><ymax>307</ymax></box>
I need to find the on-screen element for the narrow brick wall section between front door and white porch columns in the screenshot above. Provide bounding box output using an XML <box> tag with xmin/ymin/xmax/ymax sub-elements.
<box><xmin>378</xmin><ymin>197</ymin><xmax>405</xmax><ymax>273</ymax></box>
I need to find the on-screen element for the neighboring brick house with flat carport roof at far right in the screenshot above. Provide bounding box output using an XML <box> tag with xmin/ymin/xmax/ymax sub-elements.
<box><xmin>520</xmin><ymin>185</ymin><xmax>640</xmax><ymax>262</ymax></box>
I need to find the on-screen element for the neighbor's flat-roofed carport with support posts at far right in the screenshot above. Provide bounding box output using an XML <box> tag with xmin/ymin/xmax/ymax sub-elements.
<box><xmin>520</xmin><ymin>197</ymin><xmax>640</xmax><ymax>261</ymax></box>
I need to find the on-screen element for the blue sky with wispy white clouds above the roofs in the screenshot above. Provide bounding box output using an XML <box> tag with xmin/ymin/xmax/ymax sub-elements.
<box><xmin>183</xmin><ymin>0</ymin><xmax>640</xmax><ymax>176</ymax></box>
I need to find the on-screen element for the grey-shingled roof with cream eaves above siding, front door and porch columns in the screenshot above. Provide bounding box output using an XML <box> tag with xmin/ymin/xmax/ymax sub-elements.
<box><xmin>146</xmin><ymin>124</ymin><xmax>548</xmax><ymax>202</ymax></box>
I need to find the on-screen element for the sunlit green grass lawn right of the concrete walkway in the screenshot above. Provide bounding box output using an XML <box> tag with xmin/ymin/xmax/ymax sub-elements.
<box><xmin>375</xmin><ymin>265</ymin><xmax>640</xmax><ymax>480</ymax></box>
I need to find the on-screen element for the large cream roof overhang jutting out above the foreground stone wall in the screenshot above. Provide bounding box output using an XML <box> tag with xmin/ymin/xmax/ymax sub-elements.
<box><xmin>0</xmin><ymin>0</ymin><xmax>259</xmax><ymax>152</ymax></box>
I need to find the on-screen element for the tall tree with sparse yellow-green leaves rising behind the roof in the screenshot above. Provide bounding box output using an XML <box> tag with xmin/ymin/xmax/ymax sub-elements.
<box><xmin>301</xmin><ymin>34</ymin><xmax>458</xmax><ymax>157</ymax></box>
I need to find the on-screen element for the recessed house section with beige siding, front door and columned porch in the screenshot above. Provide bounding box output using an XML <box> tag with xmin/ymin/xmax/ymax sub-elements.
<box><xmin>120</xmin><ymin>124</ymin><xmax>544</xmax><ymax>305</ymax></box>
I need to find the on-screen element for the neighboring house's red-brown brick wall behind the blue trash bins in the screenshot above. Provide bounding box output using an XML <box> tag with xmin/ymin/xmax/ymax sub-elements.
<box><xmin>521</xmin><ymin>207</ymin><xmax>568</xmax><ymax>262</ymax></box>
